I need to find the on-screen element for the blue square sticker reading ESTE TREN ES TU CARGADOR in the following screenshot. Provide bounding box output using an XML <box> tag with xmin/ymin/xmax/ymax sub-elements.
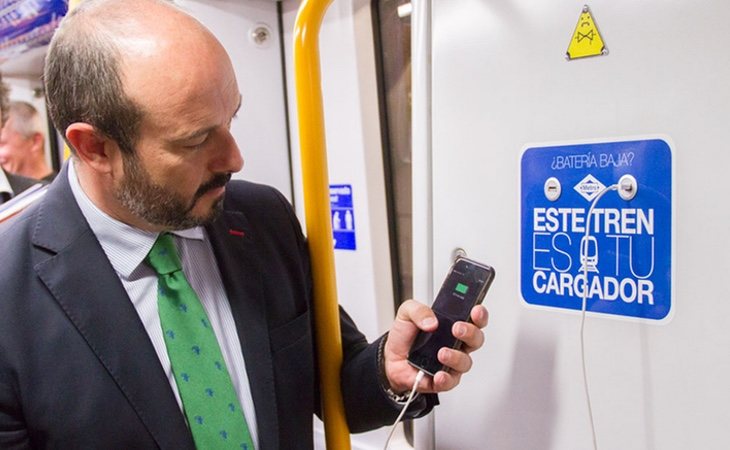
<box><xmin>520</xmin><ymin>138</ymin><xmax>674</xmax><ymax>321</ymax></box>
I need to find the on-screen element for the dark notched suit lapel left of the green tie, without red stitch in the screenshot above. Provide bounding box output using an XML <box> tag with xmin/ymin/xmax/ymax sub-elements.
<box><xmin>33</xmin><ymin>170</ymin><xmax>194</xmax><ymax>449</ymax></box>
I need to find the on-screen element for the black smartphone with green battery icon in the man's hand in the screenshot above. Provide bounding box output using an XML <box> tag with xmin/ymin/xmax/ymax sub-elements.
<box><xmin>408</xmin><ymin>257</ymin><xmax>494</xmax><ymax>376</ymax></box>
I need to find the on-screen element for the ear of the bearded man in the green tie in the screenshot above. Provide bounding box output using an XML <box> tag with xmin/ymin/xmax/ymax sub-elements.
<box><xmin>66</xmin><ymin>122</ymin><xmax>119</xmax><ymax>173</ymax></box>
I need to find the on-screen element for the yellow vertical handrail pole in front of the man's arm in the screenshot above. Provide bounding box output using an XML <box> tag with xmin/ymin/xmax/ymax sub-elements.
<box><xmin>294</xmin><ymin>0</ymin><xmax>350</xmax><ymax>450</ymax></box>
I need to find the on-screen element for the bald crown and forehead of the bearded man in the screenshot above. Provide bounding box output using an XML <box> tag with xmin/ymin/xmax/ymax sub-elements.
<box><xmin>90</xmin><ymin>1</ymin><xmax>239</xmax><ymax>134</ymax></box>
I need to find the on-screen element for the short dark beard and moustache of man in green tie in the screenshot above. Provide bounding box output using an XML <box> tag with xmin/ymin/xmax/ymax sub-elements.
<box><xmin>114</xmin><ymin>155</ymin><xmax>231</xmax><ymax>230</ymax></box>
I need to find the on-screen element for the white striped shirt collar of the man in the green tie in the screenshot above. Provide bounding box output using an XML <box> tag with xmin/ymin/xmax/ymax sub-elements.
<box><xmin>68</xmin><ymin>161</ymin><xmax>204</xmax><ymax>279</ymax></box>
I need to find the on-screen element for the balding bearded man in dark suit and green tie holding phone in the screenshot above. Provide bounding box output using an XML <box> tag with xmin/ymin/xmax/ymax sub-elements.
<box><xmin>0</xmin><ymin>0</ymin><xmax>487</xmax><ymax>450</ymax></box>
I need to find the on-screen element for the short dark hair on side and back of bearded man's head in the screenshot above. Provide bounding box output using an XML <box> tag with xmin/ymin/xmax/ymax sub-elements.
<box><xmin>43</xmin><ymin>0</ymin><xmax>148</xmax><ymax>154</ymax></box>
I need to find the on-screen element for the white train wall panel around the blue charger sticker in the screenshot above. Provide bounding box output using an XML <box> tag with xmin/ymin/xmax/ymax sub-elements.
<box><xmin>414</xmin><ymin>0</ymin><xmax>730</xmax><ymax>450</ymax></box>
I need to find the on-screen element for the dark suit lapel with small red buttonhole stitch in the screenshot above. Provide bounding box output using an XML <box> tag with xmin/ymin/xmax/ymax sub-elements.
<box><xmin>208</xmin><ymin>211</ymin><xmax>280</xmax><ymax>448</ymax></box>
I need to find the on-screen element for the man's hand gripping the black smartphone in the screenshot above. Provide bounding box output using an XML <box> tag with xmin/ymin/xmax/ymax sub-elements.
<box><xmin>384</xmin><ymin>300</ymin><xmax>489</xmax><ymax>393</ymax></box>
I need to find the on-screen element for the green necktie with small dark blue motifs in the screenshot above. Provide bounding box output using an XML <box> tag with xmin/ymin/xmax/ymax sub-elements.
<box><xmin>145</xmin><ymin>233</ymin><xmax>254</xmax><ymax>450</ymax></box>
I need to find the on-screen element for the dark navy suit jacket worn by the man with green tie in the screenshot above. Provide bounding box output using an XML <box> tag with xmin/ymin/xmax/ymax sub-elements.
<box><xmin>0</xmin><ymin>170</ymin><xmax>433</xmax><ymax>450</ymax></box>
